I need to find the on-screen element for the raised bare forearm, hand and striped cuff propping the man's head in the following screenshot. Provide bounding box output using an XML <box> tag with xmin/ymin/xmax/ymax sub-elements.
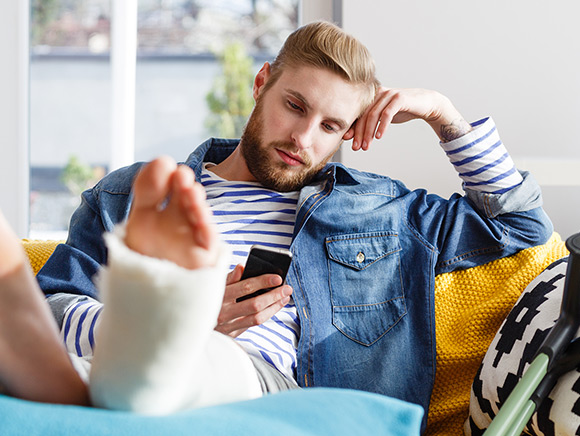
<box><xmin>345</xmin><ymin>88</ymin><xmax>523</xmax><ymax>196</ymax></box>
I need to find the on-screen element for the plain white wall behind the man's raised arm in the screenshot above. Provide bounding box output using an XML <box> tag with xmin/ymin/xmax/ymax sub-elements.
<box><xmin>342</xmin><ymin>0</ymin><xmax>580</xmax><ymax>237</ymax></box>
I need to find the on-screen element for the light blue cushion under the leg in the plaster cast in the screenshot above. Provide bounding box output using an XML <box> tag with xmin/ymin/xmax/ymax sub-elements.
<box><xmin>0</xmin><ymin>388</ymin><xmax>423</xmax><ymax>436</ymax></box>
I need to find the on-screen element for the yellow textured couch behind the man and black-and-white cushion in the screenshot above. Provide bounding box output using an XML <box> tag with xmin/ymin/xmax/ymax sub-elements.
<box><xmin>23</xmin><ymin>237</ymin><xmax>568</xmax><ymax>436</ymax></box>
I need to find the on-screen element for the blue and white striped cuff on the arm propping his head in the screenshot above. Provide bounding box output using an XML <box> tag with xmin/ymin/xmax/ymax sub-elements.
<box><xmin>441</xmin><ymin>117</ymin><xmax>523</xmax><ymax>194</ymax></box>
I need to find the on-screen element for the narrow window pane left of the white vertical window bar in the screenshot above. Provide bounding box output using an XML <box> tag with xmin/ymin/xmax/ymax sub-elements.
<box><xmin>30</xmin><ymin>0</ymin><xmax>110</xmax><ymax>239</ymax></box>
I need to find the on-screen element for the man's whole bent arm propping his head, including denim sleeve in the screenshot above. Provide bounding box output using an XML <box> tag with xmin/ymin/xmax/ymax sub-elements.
<box><xmin>345</xmin><ymin>88</ymin><xmax>553</xmax><ymax>273</ymax></box>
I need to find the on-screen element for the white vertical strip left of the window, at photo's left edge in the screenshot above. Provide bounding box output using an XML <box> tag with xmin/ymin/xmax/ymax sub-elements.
<box><xmin>0</xmin><ymin>0</ymin><xmax>29</xmax><ymax>237</ymax></box>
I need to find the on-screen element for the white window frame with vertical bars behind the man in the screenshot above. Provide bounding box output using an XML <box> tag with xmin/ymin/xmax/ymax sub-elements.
<box><xmin>7</xmin><ymin>0</ymin><xmax>342</xmax><ymax>238</ymax></box>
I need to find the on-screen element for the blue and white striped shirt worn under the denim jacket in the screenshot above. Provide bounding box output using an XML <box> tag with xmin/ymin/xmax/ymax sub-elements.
<box><xmin>61</xmin><ymin>118</ymin><xmax>522</xmax><ymax>384</ymax></box>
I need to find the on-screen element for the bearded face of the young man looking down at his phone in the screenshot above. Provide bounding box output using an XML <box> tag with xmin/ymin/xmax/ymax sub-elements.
<box><xmin>240</xmin><ymin>65</ymin><xmax>364</xmax><ymax>191</ymax></box>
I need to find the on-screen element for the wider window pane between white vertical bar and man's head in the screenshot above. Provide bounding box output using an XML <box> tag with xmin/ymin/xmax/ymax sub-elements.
<box><xmin>135</xmin><ymin>0</ymin><xmax>298</xmax><ymax>161</ymax></box>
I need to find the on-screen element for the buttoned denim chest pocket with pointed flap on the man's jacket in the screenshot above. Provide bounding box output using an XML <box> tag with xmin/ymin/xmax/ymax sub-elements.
<box><xmin>326</xmin><ymin>232</ymin><xmax>407</xmax><ymax>346</ymax></box>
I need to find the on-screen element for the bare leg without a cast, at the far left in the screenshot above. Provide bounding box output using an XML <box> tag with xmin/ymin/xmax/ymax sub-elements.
<box><xmin>0</xmin><ymin>214</ymin><xmax>88</xmax><ymax>404</ymax></box>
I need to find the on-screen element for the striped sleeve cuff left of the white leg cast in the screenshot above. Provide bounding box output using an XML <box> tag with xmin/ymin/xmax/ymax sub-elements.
<box><xmin>60</xmin><ymin>298</ymin><xmax>103</xmax><ymax>358</ymax></box>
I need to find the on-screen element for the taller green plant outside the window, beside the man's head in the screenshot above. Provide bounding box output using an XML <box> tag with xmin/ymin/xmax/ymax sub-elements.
<box><xmin>205</xmin><ymin>42</ymin><xmax>254</xmax><ymax>138</ymax></box>
